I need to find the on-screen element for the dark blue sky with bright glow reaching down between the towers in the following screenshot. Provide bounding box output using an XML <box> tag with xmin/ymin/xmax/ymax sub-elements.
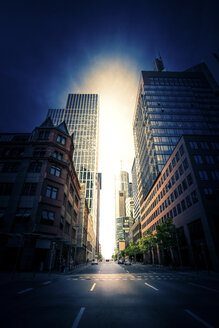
<box><xmin>0</xmin><ymin>0</ymin><xmax>219</xmax><ymax>257</ymax></box>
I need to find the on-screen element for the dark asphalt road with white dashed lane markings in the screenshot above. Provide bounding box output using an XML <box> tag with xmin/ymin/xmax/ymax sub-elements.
<box><xmin>0</xmin><ymin>262</ymin><xmax>219</xmax><ymax>328</ymax></box>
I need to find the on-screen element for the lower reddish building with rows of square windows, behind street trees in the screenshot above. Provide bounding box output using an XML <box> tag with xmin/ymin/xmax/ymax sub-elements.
<box><xmin>141</xmin><ymin>135</ymin><xmax>219</xmax><ymax>269</ymax></box>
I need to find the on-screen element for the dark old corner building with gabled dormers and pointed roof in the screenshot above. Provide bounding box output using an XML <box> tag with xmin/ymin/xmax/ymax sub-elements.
<box><xmin>0</xmin><ymin>119</ymin><xmax>80</xmax><ymax>270</ymax></box>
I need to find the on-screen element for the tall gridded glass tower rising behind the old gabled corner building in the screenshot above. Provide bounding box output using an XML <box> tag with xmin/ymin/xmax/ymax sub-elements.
<box><xmin>47</xmin><ymin>94</ymin><xmax>99</xmax><ymax>232</ymax></box>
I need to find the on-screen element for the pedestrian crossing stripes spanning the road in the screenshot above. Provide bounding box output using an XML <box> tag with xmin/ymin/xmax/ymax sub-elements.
<box><xmin>67</xmin><ymin>273</ymin><xmax>197</xmax><ymax>281</ymax></box>
